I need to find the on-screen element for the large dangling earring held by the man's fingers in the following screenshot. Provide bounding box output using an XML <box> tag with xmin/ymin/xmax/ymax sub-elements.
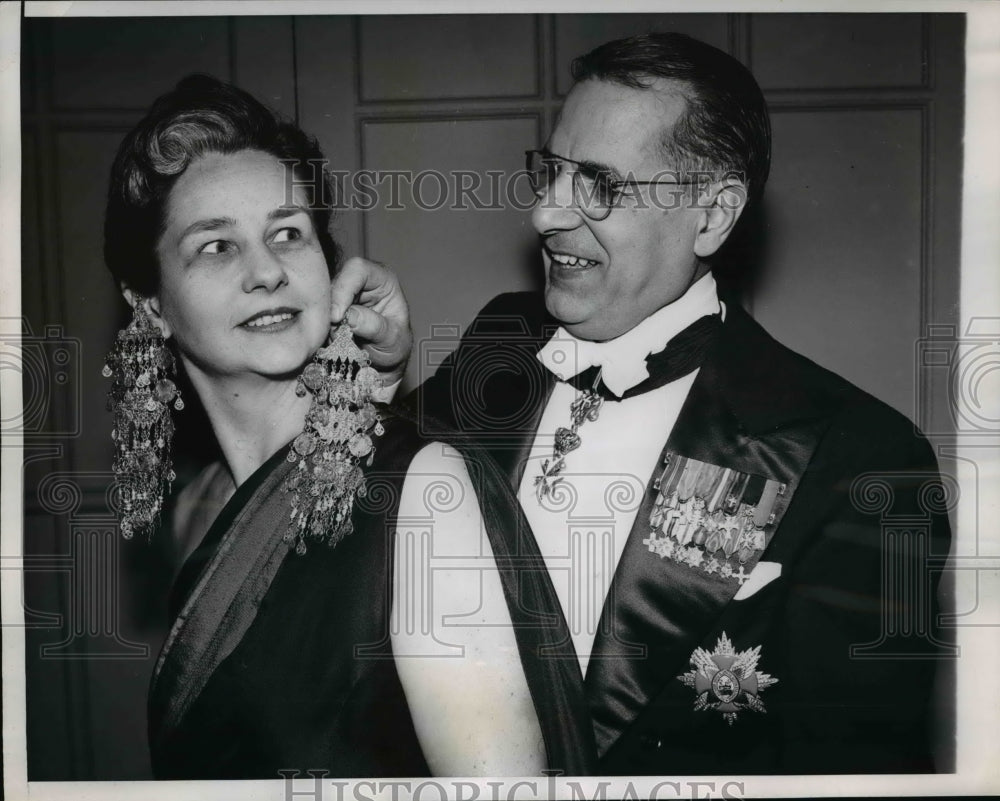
<box><xmin>284</xmin><ymin>323</ymin><xmax>385</xmax><ymax>554</ymax></box>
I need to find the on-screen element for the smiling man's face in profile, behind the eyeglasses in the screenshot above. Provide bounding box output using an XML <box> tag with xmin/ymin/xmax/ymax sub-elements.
<box><xmin>531</xmin><ymin>79</ymin><xmax>708</xmax><ymax>341</ymax></box>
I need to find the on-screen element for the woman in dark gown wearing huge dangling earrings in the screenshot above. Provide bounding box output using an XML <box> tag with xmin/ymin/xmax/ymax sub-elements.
<box><xmin>105</xmin><ymin>76</ymin><xmax>593</xmax><ymax>778</ymax></box>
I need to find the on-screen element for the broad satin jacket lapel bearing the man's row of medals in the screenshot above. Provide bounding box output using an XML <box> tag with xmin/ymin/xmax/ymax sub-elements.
<box><xmin>585</xmin><ymin>304</ymin><xmax>827</xmax><ymax>755</ymax></box>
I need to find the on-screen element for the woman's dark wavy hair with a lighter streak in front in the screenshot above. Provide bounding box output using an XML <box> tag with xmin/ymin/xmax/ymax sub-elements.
<box><xmin>104</xmin><ymin>75</ymin><xmax>340</xmax><ymax>296</ymax></box>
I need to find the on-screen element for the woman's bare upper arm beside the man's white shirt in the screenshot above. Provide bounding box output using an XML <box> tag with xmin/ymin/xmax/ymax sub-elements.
<box><xmin>392</xmin><ymin>443</ymin><xmax>545</xmax><ymax>776</ymax></box>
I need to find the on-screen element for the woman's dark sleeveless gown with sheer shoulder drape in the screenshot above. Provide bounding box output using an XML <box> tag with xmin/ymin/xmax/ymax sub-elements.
<box><xmin>149</xmin><ymin>411</ymin><xmax>593</xmax><ymax>779</ymax></box>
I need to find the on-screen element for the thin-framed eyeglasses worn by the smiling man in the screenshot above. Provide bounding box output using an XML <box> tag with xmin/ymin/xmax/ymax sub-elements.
<box><xmin>524</xmin><ymin>150</ymin><xmax>698</xmax><ymax>222</ymax></box>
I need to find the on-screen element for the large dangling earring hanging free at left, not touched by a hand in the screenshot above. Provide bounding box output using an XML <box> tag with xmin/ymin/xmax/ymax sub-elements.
<box><xmin>101</xmin><ymin>296</ymin><xmax>184</xmax><ymax>539</ymax></box>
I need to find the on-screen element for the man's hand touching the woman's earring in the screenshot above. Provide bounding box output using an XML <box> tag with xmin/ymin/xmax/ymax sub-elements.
<box><xmin>330</xmin><ymin>256</ymin><xmax>413</xmax><ymax>386</ymax></box>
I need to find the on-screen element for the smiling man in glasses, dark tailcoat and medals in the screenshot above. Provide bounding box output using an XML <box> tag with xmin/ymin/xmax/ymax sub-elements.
<box><xmin>341</xmin><ymin>34</ymin><xmax>949</xmax><ymax>774</ymax></box>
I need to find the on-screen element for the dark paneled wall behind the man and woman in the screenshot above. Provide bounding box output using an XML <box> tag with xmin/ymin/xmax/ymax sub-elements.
<box><xmin>23</xmin><ymin>14</ymin><xmax>963</xmax><ymax>779</ymax></box>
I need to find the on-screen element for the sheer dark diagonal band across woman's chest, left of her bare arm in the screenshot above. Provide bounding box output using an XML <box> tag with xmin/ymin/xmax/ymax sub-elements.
<box><xmin>150</xmin><ymin>450</ymin><xmax>293</xmax><ymax>746</ymax></box>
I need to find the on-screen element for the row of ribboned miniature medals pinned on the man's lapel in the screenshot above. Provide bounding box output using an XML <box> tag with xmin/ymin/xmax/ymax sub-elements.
<box><xmin>643</xmin><ymin>454</ymin><xmax>785</xmax><ymax>585</ymax></box>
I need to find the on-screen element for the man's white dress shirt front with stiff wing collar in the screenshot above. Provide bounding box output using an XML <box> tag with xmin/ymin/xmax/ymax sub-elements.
<box><xmin>518</xmin><ymin>273</ymin><xmax>721</xmax><ymax>673</ymax></box>
